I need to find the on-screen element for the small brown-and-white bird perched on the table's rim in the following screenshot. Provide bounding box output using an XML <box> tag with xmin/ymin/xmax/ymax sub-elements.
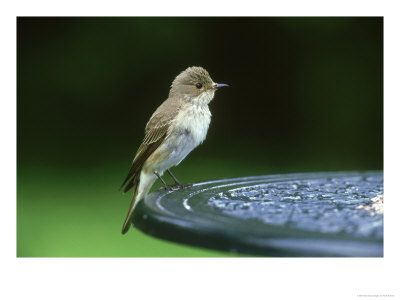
<box><xmin>120</xmin><ymin>67</ymin><xmax>228</xmax><ymax>234</ymax></box>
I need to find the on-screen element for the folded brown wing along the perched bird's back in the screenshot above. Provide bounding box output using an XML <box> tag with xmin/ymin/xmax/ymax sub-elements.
<box><xmin>120</xmin><ymin>99</ymin><xmax>179</xmax><ymax>193</ymax></box>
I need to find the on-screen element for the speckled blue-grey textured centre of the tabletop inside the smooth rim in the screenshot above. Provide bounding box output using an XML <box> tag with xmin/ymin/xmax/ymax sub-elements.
<box><xmin>208</xmin><ymin>175</ymin><xmax>383</xmax><ymax>238</ymax></box>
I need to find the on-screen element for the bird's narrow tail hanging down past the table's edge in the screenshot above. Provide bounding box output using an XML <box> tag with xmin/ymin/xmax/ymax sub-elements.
<box><xmin>122</xmin><ymin>172</ymin><xmax>157</xmax><ymax>234</ymax></box>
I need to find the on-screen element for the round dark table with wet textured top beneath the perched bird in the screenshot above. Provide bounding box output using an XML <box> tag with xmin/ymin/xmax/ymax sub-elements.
<box><xmin>133</xmin><ymin>171</ymin><xmax>383</xmax><ymax>257</ymax></box>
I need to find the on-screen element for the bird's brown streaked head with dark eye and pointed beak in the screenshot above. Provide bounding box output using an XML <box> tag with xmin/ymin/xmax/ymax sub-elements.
<box><xmin>169</xmin><ymin>67</ymin><xmax>228</xmax><ymax>104</ymax></box>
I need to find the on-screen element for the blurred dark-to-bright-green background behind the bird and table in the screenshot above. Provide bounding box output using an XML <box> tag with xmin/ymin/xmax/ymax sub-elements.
<box><xmin>17</xmin><ymin>17</ymin><xmax>383</xmax><ymax>257</ymax></box>
